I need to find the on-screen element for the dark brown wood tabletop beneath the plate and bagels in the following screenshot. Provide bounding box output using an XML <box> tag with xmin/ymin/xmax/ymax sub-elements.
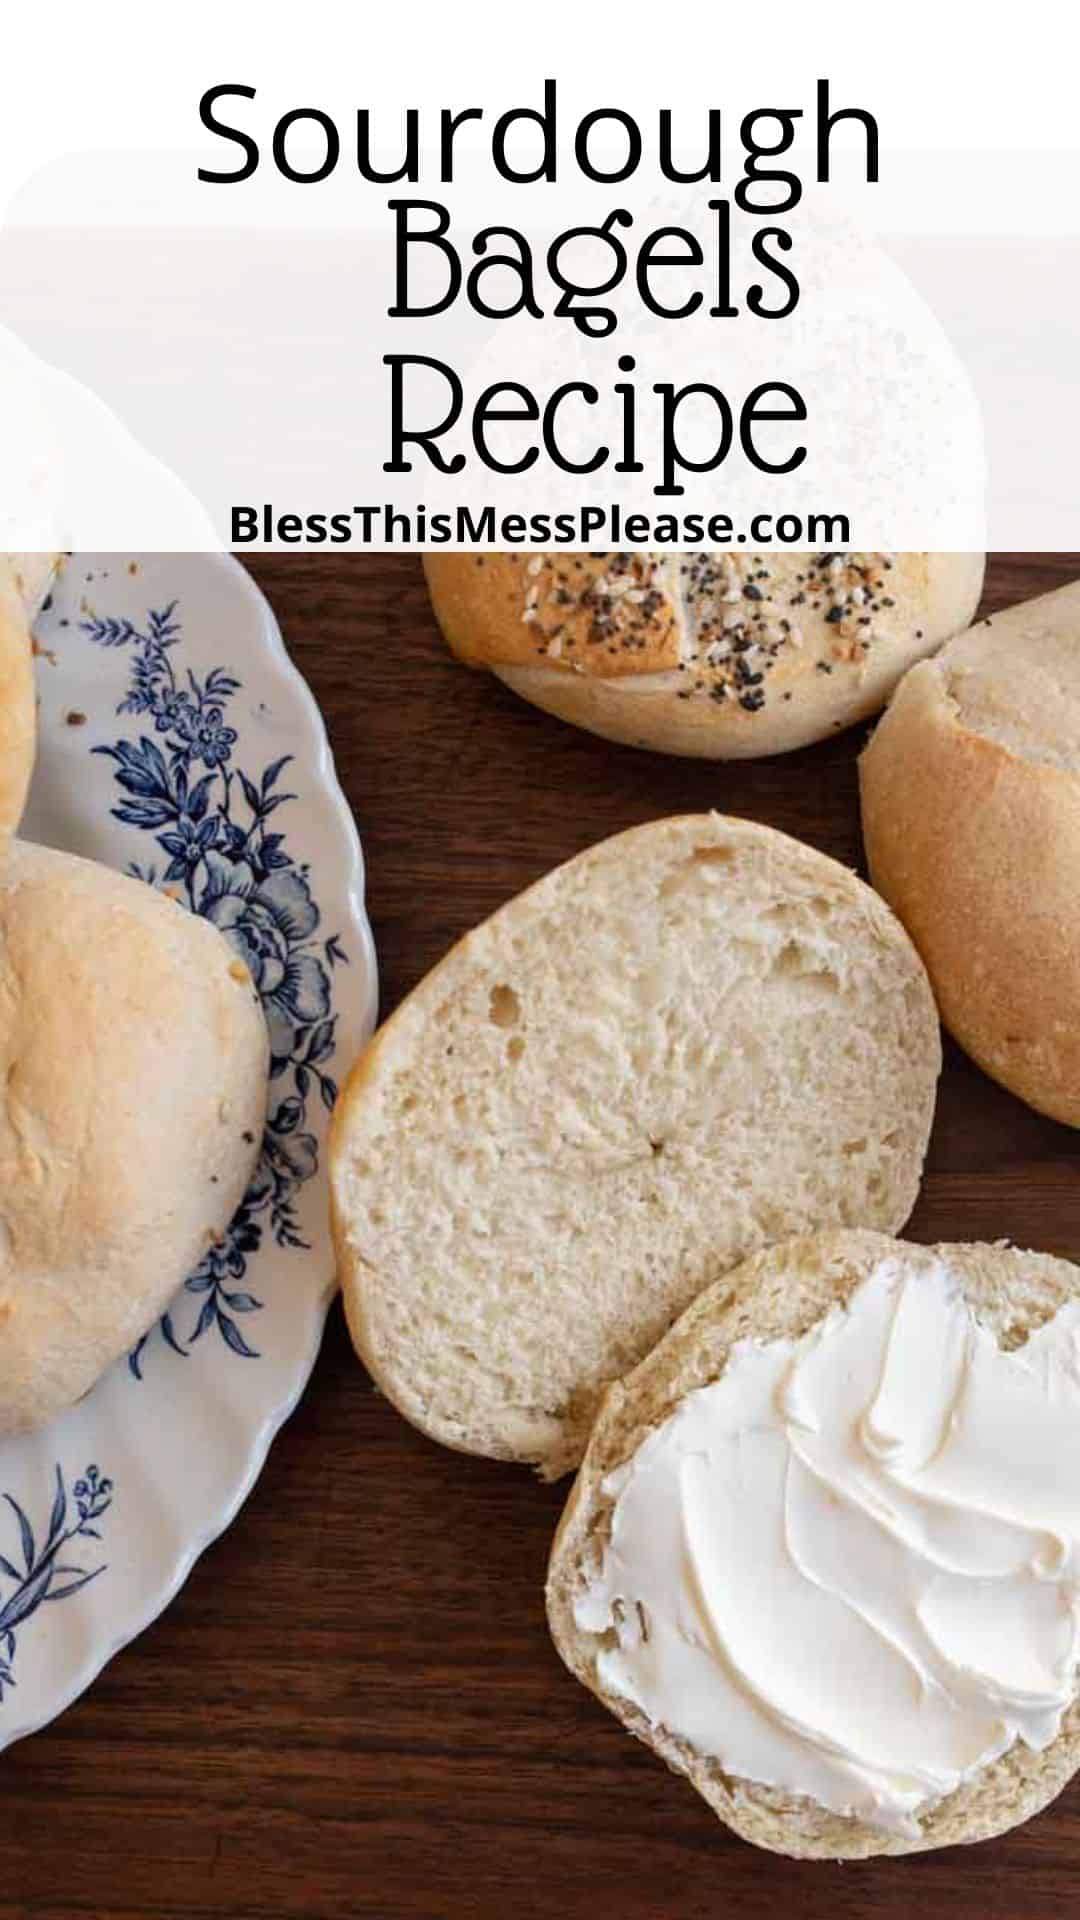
<box><xmin>0</xmin><ymin>555</ymin><xmax>1080</xmax><ymax>1920</ymax></box>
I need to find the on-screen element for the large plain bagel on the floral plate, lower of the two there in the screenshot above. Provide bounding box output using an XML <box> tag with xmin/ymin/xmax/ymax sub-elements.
<box><xmin>0</xmin><ymin>841</ymin><xmax>269</xmax><ymax>1434</ymax></box>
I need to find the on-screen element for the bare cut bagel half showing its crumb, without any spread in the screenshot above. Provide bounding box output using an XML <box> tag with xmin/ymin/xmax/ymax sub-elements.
<box><xmin>331</xmin><ymin>814</ymin><xmax>942</xmax><ymax>1476</ymax></box>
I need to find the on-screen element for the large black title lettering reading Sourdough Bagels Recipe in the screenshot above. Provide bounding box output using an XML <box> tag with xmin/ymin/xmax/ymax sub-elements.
<box><xmin>198</xmin><ymin>79</ymin><xmax>878</xmax><ymax>495</ymax></box>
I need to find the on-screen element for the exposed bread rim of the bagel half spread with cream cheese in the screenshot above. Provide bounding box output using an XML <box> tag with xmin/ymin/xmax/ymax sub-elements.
<box><xmin>548</xmin><ymin>1233</ymin><xmax>1080</xmax><ymax>1860</ymax></box>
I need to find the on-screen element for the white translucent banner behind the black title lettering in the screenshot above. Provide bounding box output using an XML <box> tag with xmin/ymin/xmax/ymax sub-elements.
<box><xmin>0</xmin><ymin>0</ymin><xmax>1080</xmax><ymax>551</ymax></box>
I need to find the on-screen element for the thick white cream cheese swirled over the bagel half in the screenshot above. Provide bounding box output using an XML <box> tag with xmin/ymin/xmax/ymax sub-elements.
<box><xmin>575</xmin><ymin>1256</ymin><xmax>1080</xmax><ymax>1836</ymax></box>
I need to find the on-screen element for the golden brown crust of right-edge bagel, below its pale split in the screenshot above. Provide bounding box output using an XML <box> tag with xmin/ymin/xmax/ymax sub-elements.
<box><xmin>859</xmin><ymin>614</ymin><xmax>1080</xmax><ymax>1127</ymax></box>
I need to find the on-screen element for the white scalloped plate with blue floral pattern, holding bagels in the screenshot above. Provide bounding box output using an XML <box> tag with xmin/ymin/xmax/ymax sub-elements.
<box><xmin>0</xmin><ymin>555</ymin><xmax>377</xmax><ymax>1747</ymax></box>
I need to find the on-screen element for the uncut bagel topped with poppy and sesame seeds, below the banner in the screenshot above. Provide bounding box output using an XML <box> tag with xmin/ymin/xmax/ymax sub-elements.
<box><xmin>425</xmin><ymin>551</ymin><xmax>984</xmax><ymax>760</ymax></box>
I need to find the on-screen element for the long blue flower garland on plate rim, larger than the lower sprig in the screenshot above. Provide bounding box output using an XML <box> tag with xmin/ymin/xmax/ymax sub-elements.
<box><xmin>81</xmin><ymin>599</ymin><xmax>346</xmax><ymax>1379</ymax></box>
